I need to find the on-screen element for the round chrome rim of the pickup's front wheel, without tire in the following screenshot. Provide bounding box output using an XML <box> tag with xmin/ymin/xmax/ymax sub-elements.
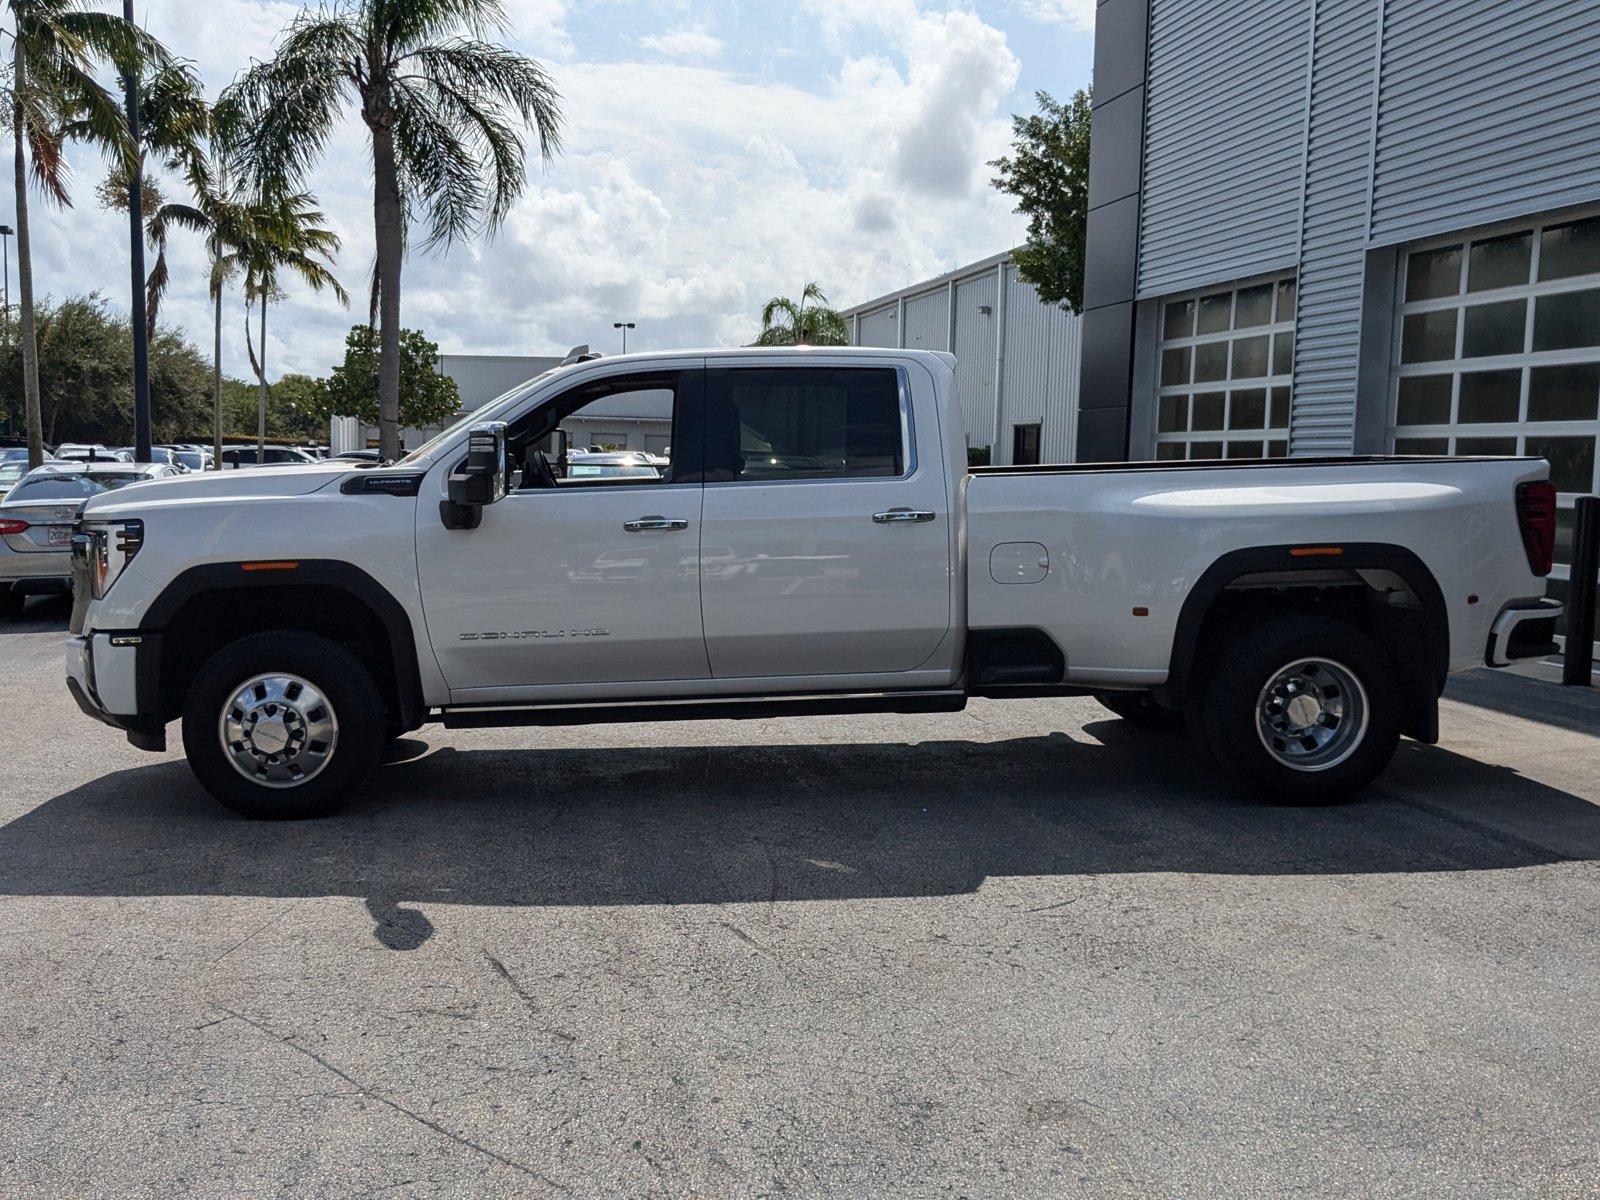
<box><xmin>218</xmin><ymin>672</ymin><xmax>339</xmax><ymax>787</ymax></box>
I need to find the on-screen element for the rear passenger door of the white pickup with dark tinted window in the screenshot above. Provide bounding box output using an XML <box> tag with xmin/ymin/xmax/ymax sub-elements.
<box><xmin>701</xmin><ymin>358</ymin><xmax>950</xmax><ymax>678</ymax></box>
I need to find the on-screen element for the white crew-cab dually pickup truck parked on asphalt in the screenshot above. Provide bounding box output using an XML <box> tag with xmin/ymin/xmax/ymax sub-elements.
<box><xmin>67</xmin><ymin>349</ymin><xmax>1560</xmax><ymax>816</ymax></box>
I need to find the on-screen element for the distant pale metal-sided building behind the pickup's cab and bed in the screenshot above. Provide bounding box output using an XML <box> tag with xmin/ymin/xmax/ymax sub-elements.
<box><xmin>845</xmin><ymin>254</ymin><xmax>1082</xmax><ymax>464</ymax></box>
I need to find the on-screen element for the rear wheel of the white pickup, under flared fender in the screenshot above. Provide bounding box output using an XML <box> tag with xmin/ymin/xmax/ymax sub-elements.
<box><xmin>1194</xmin><ymin>616</ymin><xmax>1400</xmax><ymax>805</ymax></box>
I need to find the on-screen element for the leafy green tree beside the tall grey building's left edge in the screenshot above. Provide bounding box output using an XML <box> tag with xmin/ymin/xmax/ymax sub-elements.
<box><xmin>989</xmin><ymin>90</ymin><xmax>1090</xmax><ymax>312</ymax></box>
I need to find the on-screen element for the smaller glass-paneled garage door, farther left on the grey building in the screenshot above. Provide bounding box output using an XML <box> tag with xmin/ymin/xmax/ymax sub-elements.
<box><xmin>1155</xmin><ymin>275</ymin><xmax>1294</xmax><ymax>459</ymax></box>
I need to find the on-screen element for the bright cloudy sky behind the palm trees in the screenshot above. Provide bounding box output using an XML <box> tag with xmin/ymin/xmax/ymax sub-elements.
<box><xmin>21</xmin><ymin>0</ymin><xmax>1093</xmax><ymax>376</ymax></box>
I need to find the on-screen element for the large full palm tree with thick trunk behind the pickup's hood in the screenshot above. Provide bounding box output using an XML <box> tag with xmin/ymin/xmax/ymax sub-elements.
<box><xmin>229</xmin><ymin>0</ymin><xmax>562</xmax><ymax>459</ymax></box>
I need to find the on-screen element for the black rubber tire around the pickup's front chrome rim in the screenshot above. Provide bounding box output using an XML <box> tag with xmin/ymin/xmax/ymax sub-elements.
<box><xmin>184</xmin><ymin>630</ymin><xmax>386</xmax><ymax>819</ymax></box>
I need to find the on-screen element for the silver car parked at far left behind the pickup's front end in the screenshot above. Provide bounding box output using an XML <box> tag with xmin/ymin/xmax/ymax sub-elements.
<box><xmin>0</xmin><ymin>462</ymin><xmax>182</xmax><ymax>616</ymax></box>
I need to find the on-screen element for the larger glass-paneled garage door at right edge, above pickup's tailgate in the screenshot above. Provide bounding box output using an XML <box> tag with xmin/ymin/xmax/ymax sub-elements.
<box><xmin>1389</xmin><ymin>216</ymin><xmax>1600</xmax><ymax>620</ymax></box>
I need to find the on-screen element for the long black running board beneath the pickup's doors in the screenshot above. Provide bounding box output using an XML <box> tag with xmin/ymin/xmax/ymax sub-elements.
<box><xmin>432</xmin><ymin>691</ymin><xmax>966</xmax><ymax>730</ymax></box>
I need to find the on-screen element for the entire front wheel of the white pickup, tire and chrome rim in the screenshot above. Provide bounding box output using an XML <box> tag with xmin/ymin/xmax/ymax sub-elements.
<box><xmin>184</xmin><ymin>630</ymin><xmax>384</xmax><ymax>818</ymax></box>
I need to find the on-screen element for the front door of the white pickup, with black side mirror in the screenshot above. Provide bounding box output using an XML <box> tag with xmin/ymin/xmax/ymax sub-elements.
<box><xmin>416</xmin><ymin>366</ymin><xmax>710</xmax><ymax>702</ymax></box>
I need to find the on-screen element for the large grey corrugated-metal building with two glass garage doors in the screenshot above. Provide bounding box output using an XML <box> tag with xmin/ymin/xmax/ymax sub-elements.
<box><xmin>1077</xmin><ymin>0</ymin><xmax>1600</xmax><ymax>620</ymax></box>
